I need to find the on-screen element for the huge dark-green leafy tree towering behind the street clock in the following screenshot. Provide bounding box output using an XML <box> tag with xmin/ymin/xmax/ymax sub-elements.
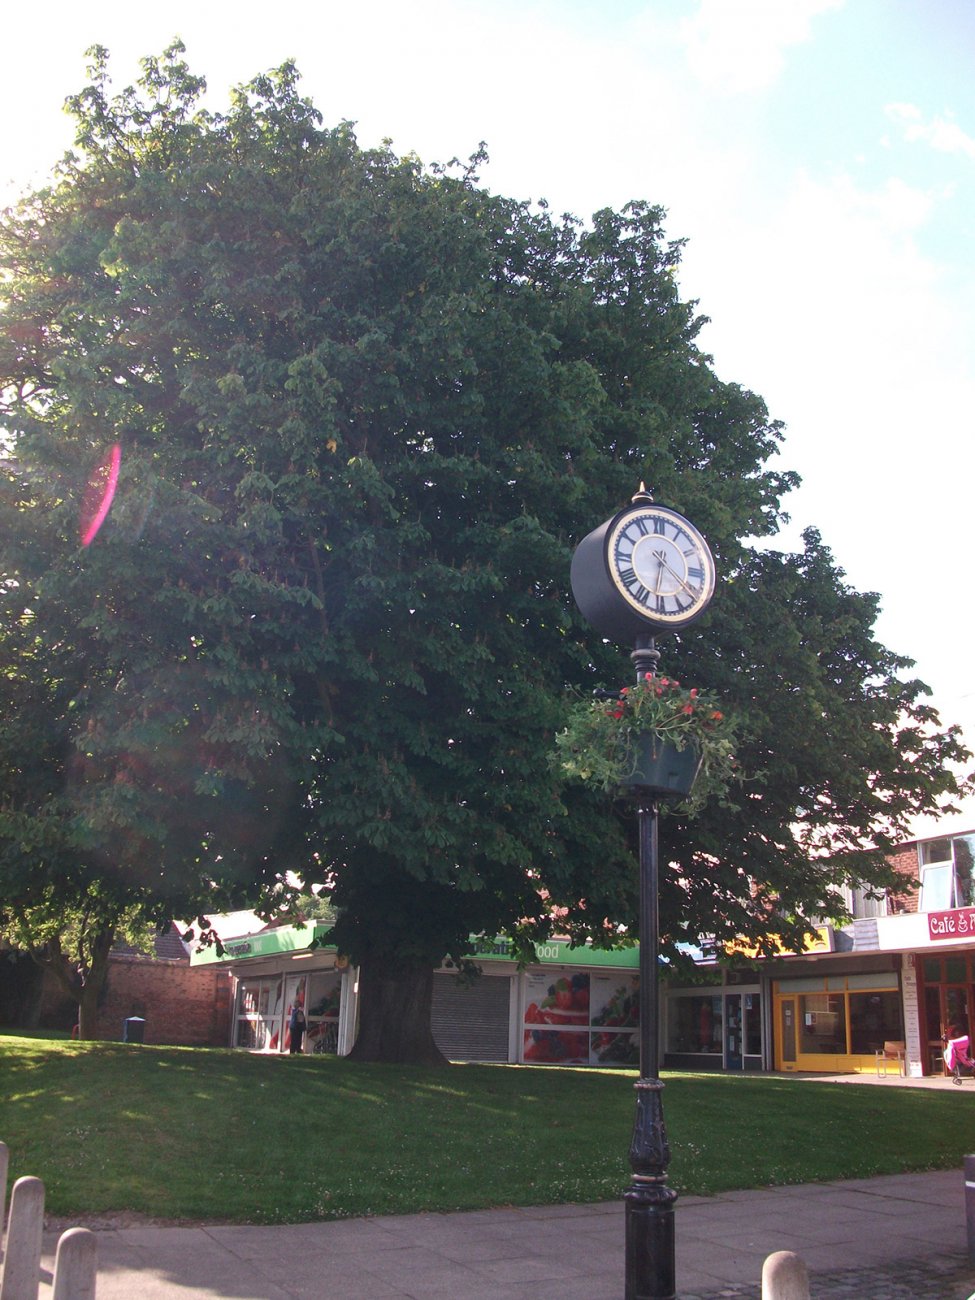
<box><xmin>0</xmin><ymin>44</ymin><xmax>959</xmax><ymax>1060</ymax></box>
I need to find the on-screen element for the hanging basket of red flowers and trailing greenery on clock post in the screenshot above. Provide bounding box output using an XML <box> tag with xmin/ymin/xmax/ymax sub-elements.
<box><xmin>555</xmin><ymin>673</ymin><xmax>736</xmax><ymax>813</ymax></box>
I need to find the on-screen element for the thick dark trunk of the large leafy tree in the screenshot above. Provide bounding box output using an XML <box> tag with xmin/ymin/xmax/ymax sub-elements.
<box><xmin>348</xmin><ymin>956</ymin><xmax>447</xmax><ymax>1065</ymax></box>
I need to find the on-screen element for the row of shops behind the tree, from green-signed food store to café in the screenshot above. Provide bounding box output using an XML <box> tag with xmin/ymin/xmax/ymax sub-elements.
<box><xmin>192</xmin><ymin>831</ymin><xmax>975</xmax><ymax>1076</ymax></box>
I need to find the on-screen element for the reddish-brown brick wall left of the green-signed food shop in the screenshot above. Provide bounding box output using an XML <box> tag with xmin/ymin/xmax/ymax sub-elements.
<box><xmin>98</xmin><ymin>957</ymin><xmax>233</xmax><ymax>1048</ymax></box>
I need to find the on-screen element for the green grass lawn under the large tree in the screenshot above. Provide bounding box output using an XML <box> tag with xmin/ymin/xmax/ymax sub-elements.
<box><xmin>0</xmin><ymin>1035</ymin><xmax>975</xmax><ymax>1223</ymax></box>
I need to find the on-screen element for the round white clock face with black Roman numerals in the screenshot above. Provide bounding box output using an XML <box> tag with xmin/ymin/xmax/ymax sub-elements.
<box><xmin>606</xmin><ymin>504</ymin><xmax>715</xmax><ymax>628</ymax></box>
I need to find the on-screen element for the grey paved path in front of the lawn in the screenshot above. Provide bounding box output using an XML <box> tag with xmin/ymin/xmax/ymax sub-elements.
<box><xmin>28</xmin><ymin>1170</ymin><xmax>975</xmax><ymax>1300</ymax></box>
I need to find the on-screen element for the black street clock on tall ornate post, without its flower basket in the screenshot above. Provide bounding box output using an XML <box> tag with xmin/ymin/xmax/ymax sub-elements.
<box><xmin>571</xmin><ymin>484</ymin><xmax>715</xmax><ymax>1300</ymax></box>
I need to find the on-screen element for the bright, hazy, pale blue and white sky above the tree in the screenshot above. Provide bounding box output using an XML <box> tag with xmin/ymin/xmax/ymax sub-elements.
<box><xmin>0</xmin><ymin>0</ymin><xmax>975</xmax><ymax>821</ymax></box>
